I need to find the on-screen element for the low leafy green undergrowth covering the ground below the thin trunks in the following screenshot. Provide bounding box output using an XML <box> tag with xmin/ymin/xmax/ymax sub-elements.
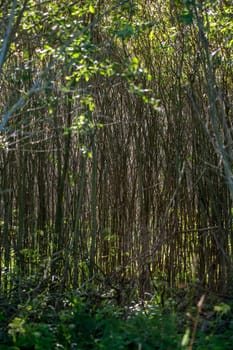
<box><xmin>0</xmin><ymin>295</ymin><xmax>233</xmax><ymax>350</ymax></box>
